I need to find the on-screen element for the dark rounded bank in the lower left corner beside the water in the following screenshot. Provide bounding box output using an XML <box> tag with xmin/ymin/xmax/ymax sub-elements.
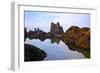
<box><xmin>24</xmin><ymin>44</ymin><xmax>47</xmax><ymax>62</ymax></box>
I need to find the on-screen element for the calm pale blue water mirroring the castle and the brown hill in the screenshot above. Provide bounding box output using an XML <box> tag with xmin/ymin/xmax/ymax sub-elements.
<box><xmin>25</xmin><ymin>37</ymin><xmax>90</xmax><ymax>60</ymax></box>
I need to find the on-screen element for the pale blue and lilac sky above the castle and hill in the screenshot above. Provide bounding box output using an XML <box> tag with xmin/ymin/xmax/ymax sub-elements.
<box><xmin>24</xmin><ymin>11</ymin><xmax>90</xmax><ymax>32</ymax></box>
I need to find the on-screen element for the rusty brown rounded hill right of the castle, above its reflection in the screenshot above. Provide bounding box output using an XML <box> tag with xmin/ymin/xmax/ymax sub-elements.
<box><xmin>63</xmin><ymin>26</ymin><xmax>90</xmax><ymax>50</ymax></box>
